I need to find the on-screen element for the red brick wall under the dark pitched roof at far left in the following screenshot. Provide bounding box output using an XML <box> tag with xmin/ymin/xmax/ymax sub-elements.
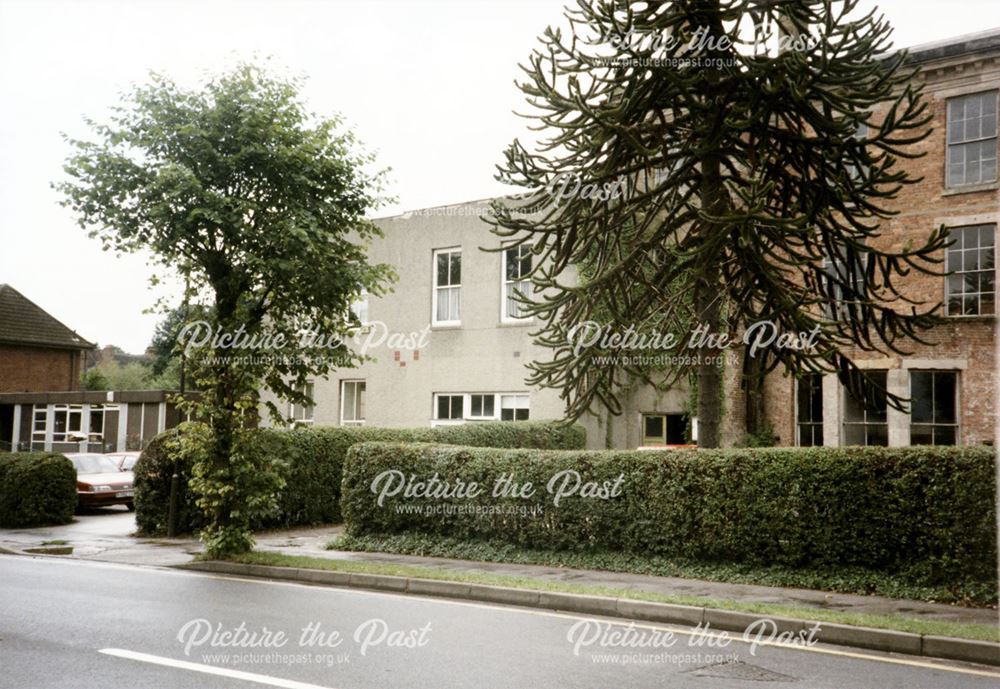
<box><xmin>0</xmin><ymin>345</ymin><xmax>81</xmax><ymax>392</ymax></box>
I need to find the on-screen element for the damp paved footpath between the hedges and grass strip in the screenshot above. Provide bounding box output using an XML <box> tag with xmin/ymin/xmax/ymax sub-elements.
<box><xmin>0</xmin><ymin>509</ymin><xmax>998</xmax><ymax>624</ymax></box>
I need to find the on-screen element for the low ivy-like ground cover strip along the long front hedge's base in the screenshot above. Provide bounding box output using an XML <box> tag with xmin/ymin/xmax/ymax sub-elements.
<box><xmin>327</xmin><ymin>534</ymin><xmax>997</xmax><ymax>607</ymax></box>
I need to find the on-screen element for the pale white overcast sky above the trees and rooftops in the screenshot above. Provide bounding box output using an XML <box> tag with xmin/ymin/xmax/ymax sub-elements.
<box><xmin>0</xmin><ymin>0</ymin><xmax>1000</xmax><ymax>353</ymax></box>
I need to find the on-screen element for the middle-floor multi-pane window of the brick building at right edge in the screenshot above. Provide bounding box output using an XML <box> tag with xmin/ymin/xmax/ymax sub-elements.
<box><xmin>945</xmin><ymin>225</ymin><xmax>996</xmax><ymax>316</ymax></box>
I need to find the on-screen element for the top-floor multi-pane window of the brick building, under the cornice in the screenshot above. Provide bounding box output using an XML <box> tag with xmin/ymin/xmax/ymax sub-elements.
<box><xmin>947</xmin><ymin>91</ymin><xmax>997</xmax><ymax>187</ymax></box>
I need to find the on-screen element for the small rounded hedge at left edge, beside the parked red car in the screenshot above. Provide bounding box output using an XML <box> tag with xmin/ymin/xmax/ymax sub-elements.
<box><xmin>0</xmin><ymin>452</ymin><xmax>77</xmax><ymax>528</ymax></box>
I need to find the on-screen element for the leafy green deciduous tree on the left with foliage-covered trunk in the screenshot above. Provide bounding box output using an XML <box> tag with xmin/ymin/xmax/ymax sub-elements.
<box><xmin>58</xmin><ymin>65</ymin><xmax>392</xmax><ymax>554</ymax></box>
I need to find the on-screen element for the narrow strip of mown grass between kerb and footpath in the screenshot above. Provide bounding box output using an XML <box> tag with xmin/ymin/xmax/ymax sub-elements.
<box><xmin>221</xmin><ymin>551</ymin><xmax>1000</xmax><ymax>641</ymax></box>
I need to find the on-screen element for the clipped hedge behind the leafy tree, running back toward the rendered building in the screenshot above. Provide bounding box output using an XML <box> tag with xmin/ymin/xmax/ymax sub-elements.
<box><xmin>134</xmin><ymin>422</ymin><xmax>586</xmax><ymax>535</ymax></box>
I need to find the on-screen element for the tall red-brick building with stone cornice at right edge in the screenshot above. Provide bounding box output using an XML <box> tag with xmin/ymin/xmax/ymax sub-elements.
<box><xmin>752</xmin><ymin>30</ymin><xmax>1000</xmax><ymax>446</ymax></box>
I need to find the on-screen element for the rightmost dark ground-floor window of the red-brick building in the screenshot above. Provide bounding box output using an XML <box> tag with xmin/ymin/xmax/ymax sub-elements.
<box><xmin>910</xmin><ymin>371</ymin><xmax>958</xmax><ymax>445</ymax></box>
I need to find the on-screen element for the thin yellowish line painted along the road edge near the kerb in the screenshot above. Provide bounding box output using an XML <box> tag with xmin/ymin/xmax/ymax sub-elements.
<box><xmin>5</xmin><ymin>556</ymin><xmax>1000</xmax><ymax>686</ymax></box>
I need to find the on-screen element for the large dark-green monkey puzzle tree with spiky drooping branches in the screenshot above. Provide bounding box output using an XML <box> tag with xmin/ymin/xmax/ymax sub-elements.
<box><xmin>493</xmin><ymin>0</ymin><xmax>947</xmax><ymax>447</ymax></box>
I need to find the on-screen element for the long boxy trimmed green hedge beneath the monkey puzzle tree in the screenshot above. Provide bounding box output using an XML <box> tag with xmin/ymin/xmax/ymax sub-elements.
<box><xmin>342</xmin><ymin>443</ymin><xmax>997</xmax><ymax>585</ymax></box>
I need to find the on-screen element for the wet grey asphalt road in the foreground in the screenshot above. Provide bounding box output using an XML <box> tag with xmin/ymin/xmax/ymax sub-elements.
<box><xmin>0</xmin><ymin>556</ymin><xmax>1000</xmax><ymax>689</ymax></box>
